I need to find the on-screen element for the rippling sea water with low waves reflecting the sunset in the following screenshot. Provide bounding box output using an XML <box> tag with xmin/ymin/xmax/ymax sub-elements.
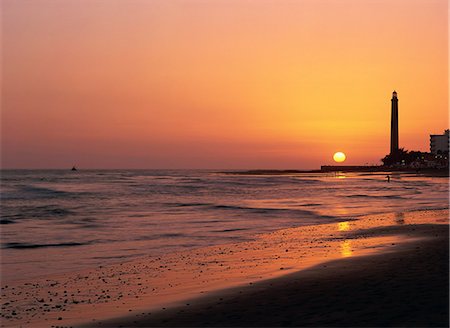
<box><xmin>0</xmin><ymin>170</ymin><xmax>449</xmax><ymax>281</ymax></box>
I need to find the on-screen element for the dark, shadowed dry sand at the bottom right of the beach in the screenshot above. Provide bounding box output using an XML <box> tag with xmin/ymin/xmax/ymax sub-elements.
<box><xmin>100</xmin><ymin>226</ymin><xmax>449</xmax><ymax>327</ymax></box>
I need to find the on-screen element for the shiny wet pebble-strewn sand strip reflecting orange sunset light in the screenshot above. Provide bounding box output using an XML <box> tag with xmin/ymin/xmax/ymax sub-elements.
<box><xmin>2</xmin><ymin>209</ymin><xmax>448</xmax><ymax>326</ymax></box>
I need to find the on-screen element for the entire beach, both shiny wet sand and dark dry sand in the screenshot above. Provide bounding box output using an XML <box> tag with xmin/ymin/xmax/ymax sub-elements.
<box><xmin>2</xmin><ymin>209</ymin><xmax>448</xmax><ymax>327</ymax></box>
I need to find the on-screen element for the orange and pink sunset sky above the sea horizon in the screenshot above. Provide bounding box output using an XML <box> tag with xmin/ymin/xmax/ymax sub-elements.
<box><xmin>1</xmin><ymin>0</ymin><xmax>449</xmax><ymax>169</ymax></box>
